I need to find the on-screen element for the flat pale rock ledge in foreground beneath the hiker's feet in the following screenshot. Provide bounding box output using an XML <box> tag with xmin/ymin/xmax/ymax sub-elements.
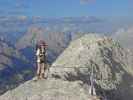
<box><xmin>0</xmin><ymin>79</ymin><xmax>95</xmax><ymax>100</ymax></box>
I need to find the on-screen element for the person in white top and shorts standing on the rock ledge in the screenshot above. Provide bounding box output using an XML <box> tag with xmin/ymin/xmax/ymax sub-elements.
<box><xmin>36</xmin><ymin>40</ymin><xmax>47</xmax><ymax>79</ymax></box>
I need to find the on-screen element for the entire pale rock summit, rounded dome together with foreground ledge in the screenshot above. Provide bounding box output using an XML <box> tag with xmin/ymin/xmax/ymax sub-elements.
<box><xmin>0</xmin><ymin>34</ymin><xmax>133</xmax><ymax>100</ymax></box>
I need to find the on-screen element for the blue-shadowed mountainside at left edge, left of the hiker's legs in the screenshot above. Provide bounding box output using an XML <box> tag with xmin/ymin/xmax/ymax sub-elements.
<box><xmin>0</xmin><ymin>38</ymin><xmax>33</xmax><ymax>94</ymax></box>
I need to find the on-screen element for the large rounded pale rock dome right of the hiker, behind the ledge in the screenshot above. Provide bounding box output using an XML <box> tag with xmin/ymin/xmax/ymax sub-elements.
<box><xmin>50</xmin><ymin>34</ymin><xmax>133</xmax><ymax>100</ymax></box>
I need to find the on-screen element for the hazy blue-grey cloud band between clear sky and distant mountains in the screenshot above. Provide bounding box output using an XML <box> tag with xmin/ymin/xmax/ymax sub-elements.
<box><xmin>0</xmin><ymin>16</ymin><xmax>131</xmax><ymax>44</ymax></box>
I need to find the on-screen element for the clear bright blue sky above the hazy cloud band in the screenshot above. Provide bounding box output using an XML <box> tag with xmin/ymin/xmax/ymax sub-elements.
<box><xmin>0</xmin><ymin>0</ymin><xmax>133</xmax><ymax>18</ymax></box>
